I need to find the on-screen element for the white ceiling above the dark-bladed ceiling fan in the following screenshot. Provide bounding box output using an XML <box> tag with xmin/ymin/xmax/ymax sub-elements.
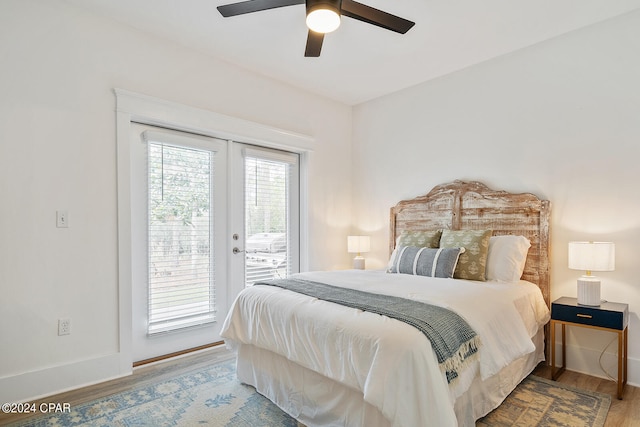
<box><xmin>66</xmin><ymin>0</ymin><xmax>640</xmax><ymax>105</ymax></box>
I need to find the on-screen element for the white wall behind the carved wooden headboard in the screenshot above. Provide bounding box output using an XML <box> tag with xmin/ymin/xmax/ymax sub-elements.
<box><xmin>353</xmin><ymin>12</ymin><xmax>640</xmax><ymax>385</ymax></box>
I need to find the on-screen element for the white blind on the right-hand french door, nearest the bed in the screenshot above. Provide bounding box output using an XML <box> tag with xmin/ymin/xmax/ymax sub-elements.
<box><xmin>244</xmin><ymin>150</ymin><xmax>298</xmax><ymax>286</ymax></box>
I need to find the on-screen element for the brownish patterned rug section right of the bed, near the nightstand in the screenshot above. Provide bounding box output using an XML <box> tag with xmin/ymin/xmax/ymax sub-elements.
<box><xmin>476</xmin><ymin>375</ymin><xmax>611</xmax><ymax>427</ymax></box>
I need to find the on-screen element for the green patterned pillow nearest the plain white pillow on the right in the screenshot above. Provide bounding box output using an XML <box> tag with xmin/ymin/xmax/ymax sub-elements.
<box><xmin>440</xmin><ymin>230</ymin><xmax>492</xmax><ymax>282</ymax></box>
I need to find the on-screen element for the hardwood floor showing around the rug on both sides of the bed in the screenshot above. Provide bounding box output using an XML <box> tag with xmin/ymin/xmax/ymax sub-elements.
<box><xmin>0</xmin><ymin>346</ymin><xmax>640</xmax><ymax>427</ymax></box>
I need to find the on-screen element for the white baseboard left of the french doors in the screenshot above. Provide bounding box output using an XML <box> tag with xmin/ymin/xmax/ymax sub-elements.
<box><xmin>0</xmin><ymin>353</ymin><xmax>132</xmax><ymax>403</ymax></box>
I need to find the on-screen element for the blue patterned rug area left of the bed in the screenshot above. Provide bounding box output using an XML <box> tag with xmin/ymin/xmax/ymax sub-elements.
<box><xmin>7</xmin><ymin>360</ymin><xmax>301</xmax><ymax>427</ymax></box>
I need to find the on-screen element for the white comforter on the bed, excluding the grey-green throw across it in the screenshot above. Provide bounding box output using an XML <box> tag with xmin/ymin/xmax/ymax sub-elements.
<box><xmin>222</xmin><ymin>270</ymin><xmax>549</xmax><ymax>426</ymax></box>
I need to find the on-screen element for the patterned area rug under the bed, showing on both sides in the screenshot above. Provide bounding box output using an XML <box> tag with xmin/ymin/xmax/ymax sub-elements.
<box><xmin>12</xmin><ymin>360</ymin><xmax>611</xmax><ymax>427</ymax></box>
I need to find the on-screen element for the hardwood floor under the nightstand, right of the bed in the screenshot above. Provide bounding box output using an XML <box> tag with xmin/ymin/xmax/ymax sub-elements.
<box><xmin>533</xmin><ymin>364</ymin><xmax>640</xmax><ymax>427</ymax></box>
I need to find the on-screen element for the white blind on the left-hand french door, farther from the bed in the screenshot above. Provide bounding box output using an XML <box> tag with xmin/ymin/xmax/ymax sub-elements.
<box><xmin>148</xmin><ymin>142</ymin><xmax>215</xmax><ymax>334</ymax></box>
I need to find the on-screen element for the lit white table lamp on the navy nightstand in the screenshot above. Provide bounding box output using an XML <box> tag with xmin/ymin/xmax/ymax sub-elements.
<box><xmin>569</xmin><ymin>242</ymin><xmax>616</xmax><ymax>307</ymax></box>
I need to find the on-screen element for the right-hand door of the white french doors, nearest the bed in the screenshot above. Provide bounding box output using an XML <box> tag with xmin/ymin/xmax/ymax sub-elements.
<box><xmin>231</xmin><ymin>143</ymin><xmax>300</xmax><ymax>293</ymax></box>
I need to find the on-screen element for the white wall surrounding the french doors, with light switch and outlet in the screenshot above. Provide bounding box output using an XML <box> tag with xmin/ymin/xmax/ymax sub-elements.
<box><xmin>0</xmin><ymin>0</ymin><xmax>351</xmax><ymax>402</ymax></box>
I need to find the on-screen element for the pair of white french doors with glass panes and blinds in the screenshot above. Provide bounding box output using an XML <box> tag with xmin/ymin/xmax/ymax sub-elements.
<box><xmin>131</xmin><ymin>124</ymin><xmax>299</xmax><ymax>361</ymax></box>
